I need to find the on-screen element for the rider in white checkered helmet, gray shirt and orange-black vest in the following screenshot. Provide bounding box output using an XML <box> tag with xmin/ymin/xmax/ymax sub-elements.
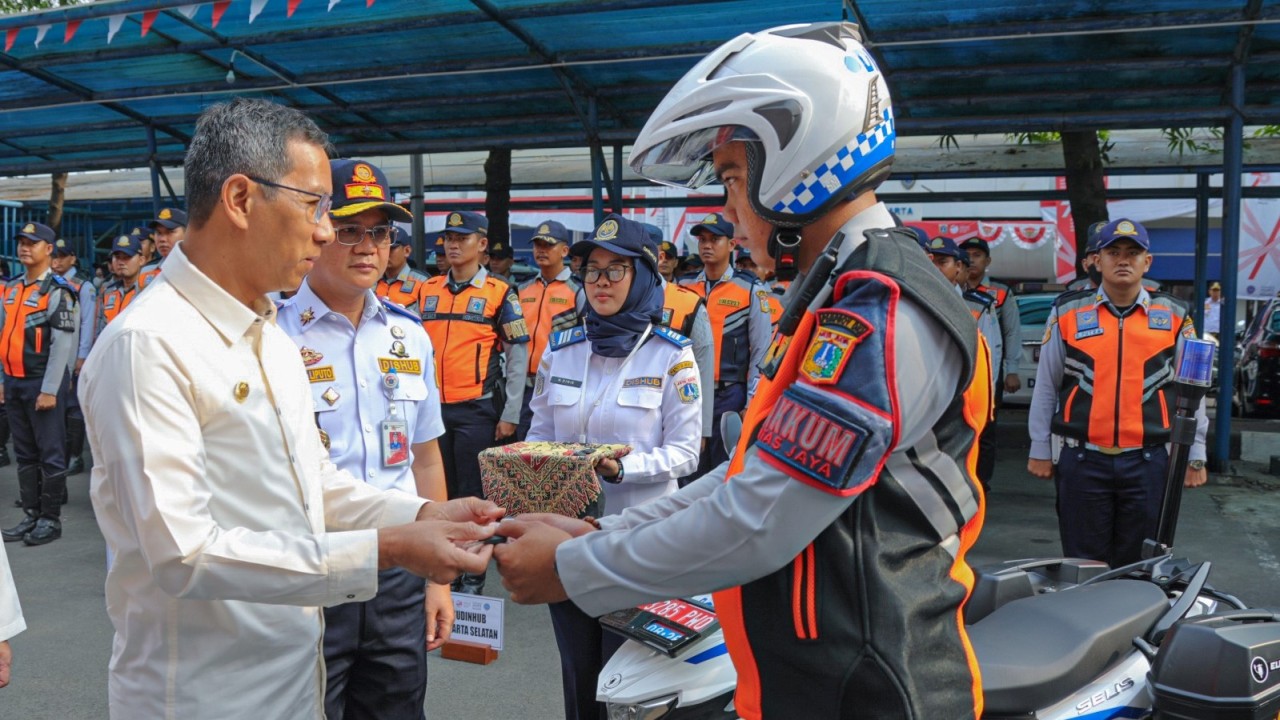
<box><xmin>495</xmin><ymin>23</ymin><xmax>989</xmax><ymax>719</ymax></box>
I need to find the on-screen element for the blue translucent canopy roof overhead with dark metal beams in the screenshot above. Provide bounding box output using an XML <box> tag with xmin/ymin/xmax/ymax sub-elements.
<box><xmin>0</xmin><ymin>0</ymin><xmax>1280</xmax><ymax>174</ymax></box>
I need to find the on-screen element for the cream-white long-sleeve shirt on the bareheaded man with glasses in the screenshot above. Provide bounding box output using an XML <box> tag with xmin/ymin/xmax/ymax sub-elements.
<box><xmin>79</xmin><ymin>246</ymin><xmax>424</xmax><ymax>720</ymax></box>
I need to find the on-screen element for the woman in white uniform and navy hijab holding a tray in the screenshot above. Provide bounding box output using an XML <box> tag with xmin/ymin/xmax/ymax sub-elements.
<box><xmin>526</xmin><ymin>215</ymin><xmax>701</xmax><ymax>720</ymax></box>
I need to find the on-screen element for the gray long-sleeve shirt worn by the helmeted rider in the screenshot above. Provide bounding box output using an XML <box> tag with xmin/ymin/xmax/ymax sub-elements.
<box><xmin>556</xmin><ymin>205</ymin><xmax>963</xmax><ymax>615</ymax></box>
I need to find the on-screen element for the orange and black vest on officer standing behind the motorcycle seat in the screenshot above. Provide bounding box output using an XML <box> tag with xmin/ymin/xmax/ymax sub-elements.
<box><xmin>1051</xmin><ymin>290</ymin><xmax>1196</xmax><ymax>448</ymax></box>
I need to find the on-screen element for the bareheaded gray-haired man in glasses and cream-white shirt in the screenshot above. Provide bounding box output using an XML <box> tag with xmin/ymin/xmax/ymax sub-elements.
<box><xmin>81</xmin><ymin>99</ymin><xmax>500</xmax><ymax>720</ymax></box>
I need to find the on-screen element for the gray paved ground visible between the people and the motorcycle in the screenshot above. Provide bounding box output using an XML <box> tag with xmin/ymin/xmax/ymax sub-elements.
<box><xmin>0</xmin><ymin>410</ymin><xmax>1280</xmax><ymax>720</ymax></box>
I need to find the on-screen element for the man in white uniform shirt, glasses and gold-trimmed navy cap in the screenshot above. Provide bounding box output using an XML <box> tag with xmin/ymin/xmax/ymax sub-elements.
<box><xmin>278</xmin><ymin>160</ymin><xmax>453</xmax><ymax>720</ymax></box>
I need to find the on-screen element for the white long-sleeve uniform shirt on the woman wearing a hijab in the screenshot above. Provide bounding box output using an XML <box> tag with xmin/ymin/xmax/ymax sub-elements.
<box><xmin>525</xmin><ymin>322</ymin><xmax>703</xmax><ymax>514</ymax></box>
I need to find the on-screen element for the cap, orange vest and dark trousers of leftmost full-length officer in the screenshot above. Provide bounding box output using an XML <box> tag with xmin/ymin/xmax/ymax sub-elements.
<box><xmin>0</xmin><ymin>223</ymin><xmax>78</xmax><ymax>544</ymax></box>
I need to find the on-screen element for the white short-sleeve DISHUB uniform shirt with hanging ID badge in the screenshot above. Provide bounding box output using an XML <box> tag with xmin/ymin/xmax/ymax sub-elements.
<box><xmin>278</xmin><ymin>275</ymin><xmax>444</xmax><ymax>495</ymax></box>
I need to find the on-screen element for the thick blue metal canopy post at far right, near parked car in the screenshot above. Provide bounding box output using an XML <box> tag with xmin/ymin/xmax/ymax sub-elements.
<box><xmin>1210</xmin><ymin>63</ymin><xmax>1244</xmax><ymax>471</ymax></box>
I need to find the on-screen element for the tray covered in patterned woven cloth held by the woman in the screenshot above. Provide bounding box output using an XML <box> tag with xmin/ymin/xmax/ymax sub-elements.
<box><xmin>480</xmin><ymin>442</ymin><xmax>631</xmax><ymax>518</ymax></box>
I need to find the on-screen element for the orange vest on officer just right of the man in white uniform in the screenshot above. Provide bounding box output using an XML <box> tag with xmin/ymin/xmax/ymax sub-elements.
<box><xmin>422</xmin><ymin>273</ymin><xmax>529</xmax><ymax>404</ymax></box>
